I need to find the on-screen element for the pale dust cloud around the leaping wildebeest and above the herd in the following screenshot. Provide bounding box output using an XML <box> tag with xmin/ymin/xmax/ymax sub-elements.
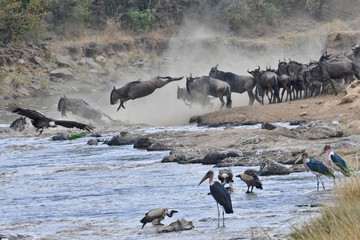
<box><xmin>69</xmin><ymin>14</ymin><xmax>358</xmax><ymax>126</ymax></box>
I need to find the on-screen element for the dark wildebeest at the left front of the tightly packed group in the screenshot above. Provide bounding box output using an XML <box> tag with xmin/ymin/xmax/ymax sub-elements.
<box><xmin>247</xmin><ymin>66</ymin><xmax>280</xmax><ymax>104</ymax></box>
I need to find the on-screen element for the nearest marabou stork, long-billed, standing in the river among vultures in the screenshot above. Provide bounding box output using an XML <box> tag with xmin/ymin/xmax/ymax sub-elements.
<box><xmin>199</xmin><ymin>170</ymin><xmax>234</xmax><ymax>227</ymax></box>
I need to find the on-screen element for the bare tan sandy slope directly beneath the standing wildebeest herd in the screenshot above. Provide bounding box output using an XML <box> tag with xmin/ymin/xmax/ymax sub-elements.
<box><xmin>195</xmin><ymin>81</ymin><xmax>360</xmax><ymax>134</ymax></box>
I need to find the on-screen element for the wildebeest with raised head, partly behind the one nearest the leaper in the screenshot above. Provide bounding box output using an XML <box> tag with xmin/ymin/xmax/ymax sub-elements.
<box><xmin>209</xmin><ymin>64</ymin><xmax>256</xmax><ymax>105</ymax></box>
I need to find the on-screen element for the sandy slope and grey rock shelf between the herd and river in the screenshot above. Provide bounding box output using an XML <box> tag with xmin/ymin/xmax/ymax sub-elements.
<box><xmin>95</xmin><ymin>81</ymin><xmax>360</xmax><ymax>172</ymax></box>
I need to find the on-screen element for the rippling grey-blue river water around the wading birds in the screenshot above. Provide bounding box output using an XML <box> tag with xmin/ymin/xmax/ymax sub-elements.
<box><xmin>0</xmin><ymin>96</ymin><xmax>333</xmax><ymax>239</ymax></box>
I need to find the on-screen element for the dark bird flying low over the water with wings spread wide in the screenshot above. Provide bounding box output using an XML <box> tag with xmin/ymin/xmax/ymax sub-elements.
<box><xmin>6</xmin><ymin>104</ymin><xmax>94</xmax><ymax>134</ymax></box>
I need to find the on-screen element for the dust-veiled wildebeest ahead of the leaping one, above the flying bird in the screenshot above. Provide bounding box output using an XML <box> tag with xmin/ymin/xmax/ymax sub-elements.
<box><xmin>57</xmin><ymin>95</ymin><xmax>114</xmax><ymax>123</ymax></box>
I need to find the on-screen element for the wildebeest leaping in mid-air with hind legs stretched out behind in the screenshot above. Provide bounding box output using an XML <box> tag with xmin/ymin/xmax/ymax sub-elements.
<box><xmin>110</xmin><ymin>77</ymin><xmax>183</xmax><ymax>111</ymax></box>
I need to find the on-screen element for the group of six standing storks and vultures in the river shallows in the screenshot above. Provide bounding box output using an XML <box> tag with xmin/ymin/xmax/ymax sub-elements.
<box><xmin>140</xmin><ymin>145</ymin><xmax>351</xmax><ymax>228</ymax></box>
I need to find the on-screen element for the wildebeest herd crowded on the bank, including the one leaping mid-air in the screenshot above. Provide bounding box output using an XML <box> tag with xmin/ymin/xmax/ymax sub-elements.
<box><xmin>110</xmin><ymin>45</ymin><xmax>360</xmax><ymax>110</ymax></box>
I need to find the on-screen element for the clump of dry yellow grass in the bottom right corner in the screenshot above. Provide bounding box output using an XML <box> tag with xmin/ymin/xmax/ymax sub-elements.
<box><xmin>289</xmin><ymin>176</ymin><xmax>360</xmax><ymax>240</ymax></box>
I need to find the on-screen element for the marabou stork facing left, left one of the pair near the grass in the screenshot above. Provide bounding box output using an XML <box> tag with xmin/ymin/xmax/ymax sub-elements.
<box><xmin>294</xmin><ymin>152</ymin><xmax>335</xmax><ymax>191</ymax></box>
